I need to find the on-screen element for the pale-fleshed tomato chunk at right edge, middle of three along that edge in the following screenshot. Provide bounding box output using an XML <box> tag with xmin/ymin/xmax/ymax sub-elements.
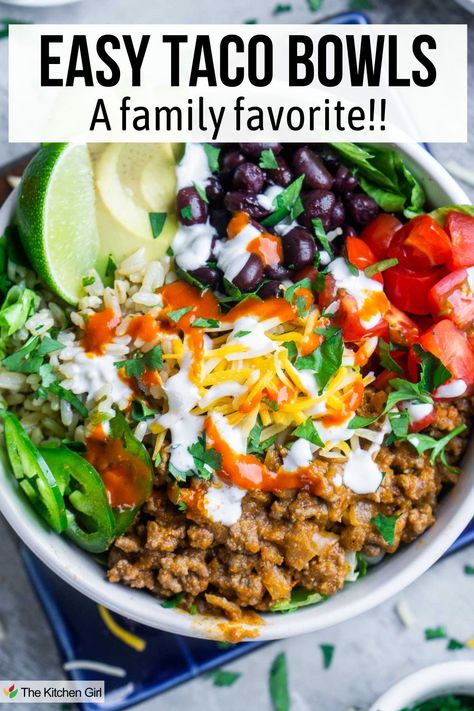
<box><xmin>429</xmin><ymin>269</ymin><xmax>474</xmax><ymax>329</ymax></box>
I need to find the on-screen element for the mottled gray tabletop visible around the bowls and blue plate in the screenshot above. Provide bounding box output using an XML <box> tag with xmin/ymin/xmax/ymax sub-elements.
<box><xmin>0</xmin><ymin>0</ymin><xmax>474</xmax><ymax>711</ymax></box>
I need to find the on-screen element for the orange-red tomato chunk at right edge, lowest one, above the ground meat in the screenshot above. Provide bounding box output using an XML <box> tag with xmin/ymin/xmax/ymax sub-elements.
<box><xmin>408</xmin><ymin>318</ymin><xmax>474</xmax><ymax>394</ymax></box>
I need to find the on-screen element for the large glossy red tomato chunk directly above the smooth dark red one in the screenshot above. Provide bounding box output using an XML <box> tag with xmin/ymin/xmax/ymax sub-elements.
<box><xmin>388</xmin><ymin>215</ymin><xmax>452</xmax><ymax>272</ymax></box>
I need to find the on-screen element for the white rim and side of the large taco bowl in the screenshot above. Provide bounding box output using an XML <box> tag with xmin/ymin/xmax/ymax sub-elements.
<box><xmin>0</xmin><ymin>145</ymin><xmax>474</xmax><ymax>640</ymax></box>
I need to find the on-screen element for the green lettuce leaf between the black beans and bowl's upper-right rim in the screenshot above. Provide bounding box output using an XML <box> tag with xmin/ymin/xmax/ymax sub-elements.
<box><xmin>331</xmin><ymin>143</ymin><xmax>426</xmax><ymax>217</ymax></box>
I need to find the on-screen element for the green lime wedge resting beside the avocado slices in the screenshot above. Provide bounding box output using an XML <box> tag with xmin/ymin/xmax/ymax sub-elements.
<box><xmin>17</xmin><ymin>143</ymin><xmax>99</xmax><ymax>304</ymax></box>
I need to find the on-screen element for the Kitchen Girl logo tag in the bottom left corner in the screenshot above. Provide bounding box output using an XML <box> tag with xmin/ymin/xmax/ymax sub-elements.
<box><xmin>0</xmin><ymin>679</ymin><xmax>105</xmax><ymax>704</ymax></box>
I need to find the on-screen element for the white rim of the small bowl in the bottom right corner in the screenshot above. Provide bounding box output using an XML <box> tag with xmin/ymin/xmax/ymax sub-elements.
<box><xmin>369</xmin><ymin>662</ymin><xmax>474</xmax><ymax>711</ymax></box>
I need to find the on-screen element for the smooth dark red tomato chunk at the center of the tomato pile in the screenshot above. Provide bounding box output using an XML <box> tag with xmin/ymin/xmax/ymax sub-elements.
<box><xmin>384</xmin><ymin>266</ymin><xmax>446</xmax><ymax>315</ymax></box>
